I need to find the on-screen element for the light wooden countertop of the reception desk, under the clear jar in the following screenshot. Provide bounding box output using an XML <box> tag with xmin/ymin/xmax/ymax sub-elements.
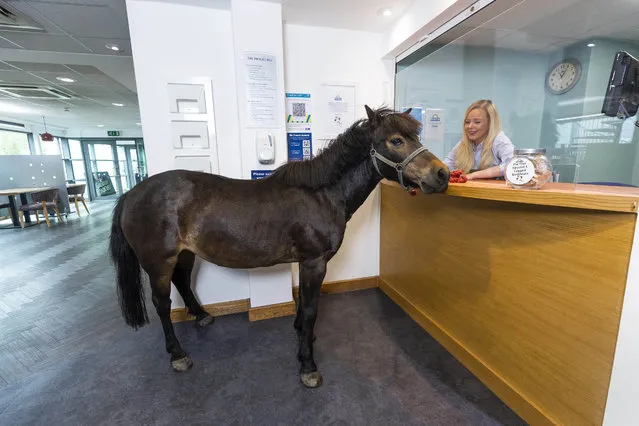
<box><xmin>383</xmin><ymin>180</ymin><xmax>639</xmax><ymax>213</ymax></box>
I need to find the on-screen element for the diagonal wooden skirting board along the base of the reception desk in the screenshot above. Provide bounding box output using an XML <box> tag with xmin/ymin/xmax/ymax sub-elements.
<box><xmin>379</xmin><ymin>277</ymin><xmax>556</xmax><ymax>425</ymax></box>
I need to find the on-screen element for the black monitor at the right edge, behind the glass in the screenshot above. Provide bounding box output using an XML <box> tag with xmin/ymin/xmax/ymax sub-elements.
<box><xmin>601</xmin><ymin>51</ymin><xmax>639</xmax><ymax>119</ymax></box>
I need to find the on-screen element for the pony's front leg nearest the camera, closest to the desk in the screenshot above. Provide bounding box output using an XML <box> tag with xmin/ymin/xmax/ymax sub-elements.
<box><xmin>296</xmin><ymin>258</ymin><xmax>326</xmax><ymax>388</ymax></box>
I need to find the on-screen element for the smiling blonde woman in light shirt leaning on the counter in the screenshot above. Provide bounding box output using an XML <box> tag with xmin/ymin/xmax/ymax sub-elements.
<box><xmin>444</xmin><ymin>99</ymin><xmax>515</xmax><ymax>180</ymax></box>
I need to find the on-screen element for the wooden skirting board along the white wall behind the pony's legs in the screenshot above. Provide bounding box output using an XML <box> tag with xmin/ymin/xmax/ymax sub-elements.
<box><xmin>171</xmin><ymin>276</ymin><xmax>378</xmax><ymax>322</ymax></box>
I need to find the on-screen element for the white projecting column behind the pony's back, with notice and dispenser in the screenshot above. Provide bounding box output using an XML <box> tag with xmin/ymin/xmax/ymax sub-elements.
<box><xmin>231</xmin><ymin>0</ymin><xmax>293</xmax><ymax>307</ymax></box>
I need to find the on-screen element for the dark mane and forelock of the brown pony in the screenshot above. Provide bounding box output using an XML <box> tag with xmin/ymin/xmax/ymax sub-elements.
<box><xmin>267</xmin><ymin>108</ymin><xmax>420</xmax><ymax>189</ymax></box>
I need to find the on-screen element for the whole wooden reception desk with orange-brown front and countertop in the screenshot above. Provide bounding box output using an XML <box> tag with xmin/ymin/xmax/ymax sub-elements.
<box><xmin>380</xmin><ymin>181</ymin><xmax>639</xmax><ymax>425</ymax></box>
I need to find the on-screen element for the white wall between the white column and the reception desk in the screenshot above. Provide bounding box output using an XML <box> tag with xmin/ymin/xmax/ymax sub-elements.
<box><xmin>284</xmin><ymin>24</ymin><xmax>393</xmax><ymax>281</ymax></box>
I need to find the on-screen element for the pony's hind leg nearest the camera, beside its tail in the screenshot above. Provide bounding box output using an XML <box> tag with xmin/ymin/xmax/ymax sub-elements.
<box><xmin>145</xmin><ymin>257</ymin><xmax>193</xmax><ymax>371</ymax></box>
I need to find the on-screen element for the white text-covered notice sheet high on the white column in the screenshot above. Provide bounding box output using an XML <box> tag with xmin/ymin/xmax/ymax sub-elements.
<box><xmin>244</xmin><ymin>52</ymin><xmax>277</xmax><ymax>127</ymax></box>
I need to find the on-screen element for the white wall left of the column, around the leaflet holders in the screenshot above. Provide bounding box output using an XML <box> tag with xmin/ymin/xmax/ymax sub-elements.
<box><xmin>127</xmin><ymin>0</ymin><xmax>249</xmax><ymax>307</ymax></box>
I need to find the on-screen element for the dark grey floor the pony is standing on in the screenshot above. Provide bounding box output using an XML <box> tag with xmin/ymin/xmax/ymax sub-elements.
<box><xmin>0</xmin><ymin>203</ymin><xmax>524</xmax><ymax>425</ymax></box>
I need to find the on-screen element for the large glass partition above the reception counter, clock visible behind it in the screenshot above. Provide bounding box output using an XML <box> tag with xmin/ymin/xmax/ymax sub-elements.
<box><xmin>395</xmin><ymin>0</ymin><xmax>639</xmax><ymax>186</ymax></box>
